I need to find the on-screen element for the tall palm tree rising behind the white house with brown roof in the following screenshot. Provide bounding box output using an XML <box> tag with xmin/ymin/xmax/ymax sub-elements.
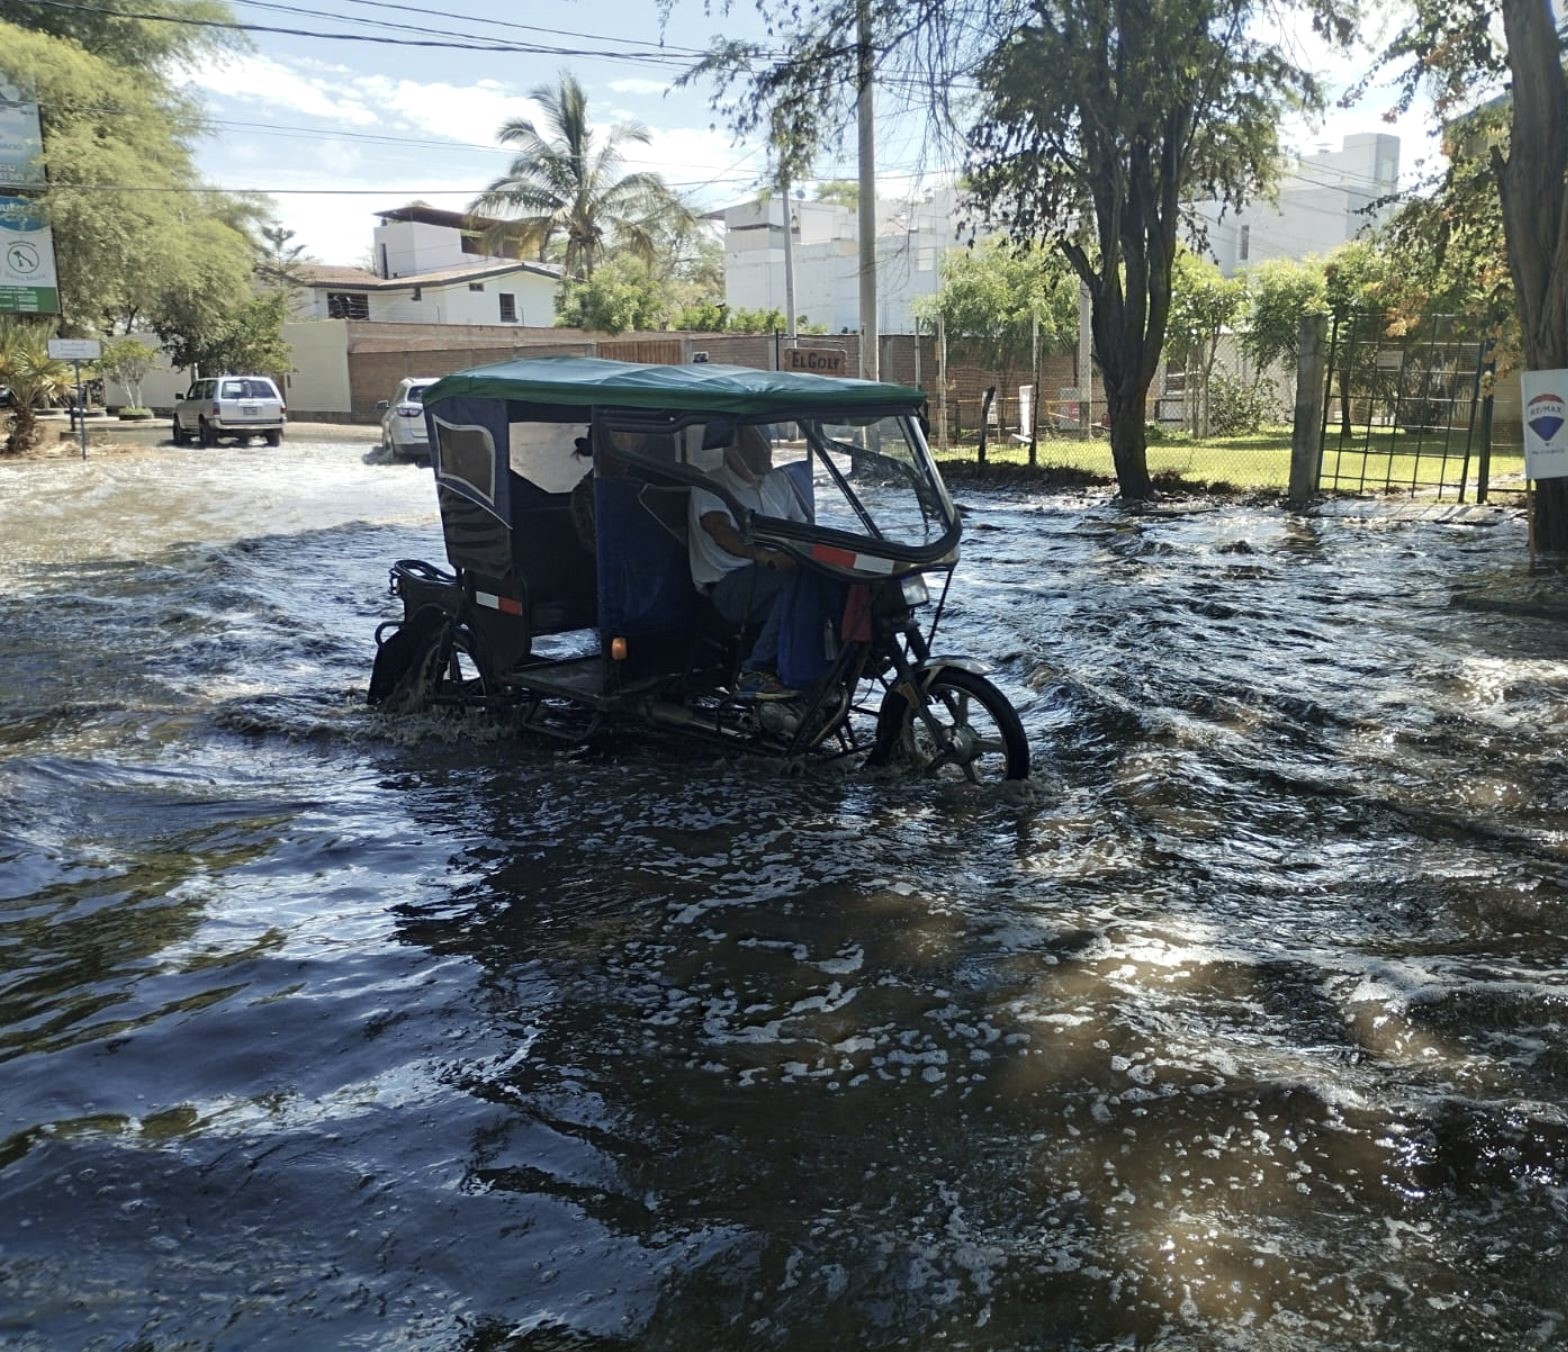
<box><xmin>469</xmin><ymin>72</ymin><xmax>693</xmax><ymax>281</ymax></box>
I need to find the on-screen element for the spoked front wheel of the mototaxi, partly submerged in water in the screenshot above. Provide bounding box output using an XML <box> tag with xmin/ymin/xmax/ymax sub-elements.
<box><xmin>872</xmin><ymin>667</ymin><xmax>1029</xmax><ymax>784</ymax></box>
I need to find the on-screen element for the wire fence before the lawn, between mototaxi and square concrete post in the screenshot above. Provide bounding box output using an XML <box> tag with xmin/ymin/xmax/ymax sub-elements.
<box><xmin>931</xmin><ymin>333</ymin><xmax>1295</xmax><ymax>488</ymax></box>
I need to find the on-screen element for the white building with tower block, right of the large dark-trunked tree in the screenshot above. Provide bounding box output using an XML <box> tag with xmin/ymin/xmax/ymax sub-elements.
<box><xmin>1198</xmin><ymin>132</ymin><xmax>1399</xmax><ymax>276</ymax></box>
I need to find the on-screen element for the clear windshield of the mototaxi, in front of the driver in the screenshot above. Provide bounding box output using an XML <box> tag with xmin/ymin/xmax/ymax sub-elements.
<box><xmin>775</xmin><ymin>417</ymin><xmax>956</xmax><ymax>547</ymax></box>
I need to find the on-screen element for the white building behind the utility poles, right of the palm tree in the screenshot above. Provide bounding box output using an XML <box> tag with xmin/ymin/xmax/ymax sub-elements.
<box><xmin>709</xmin><ymin>188</ymin><xmax>958</xmax><ymax>333</ymax></box>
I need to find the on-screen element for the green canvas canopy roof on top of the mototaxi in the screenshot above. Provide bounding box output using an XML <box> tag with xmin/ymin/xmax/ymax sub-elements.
<box><xmin>425</xmin><ymin>356</ymin><xmax>925</xmax><ymax>417</ymax></box>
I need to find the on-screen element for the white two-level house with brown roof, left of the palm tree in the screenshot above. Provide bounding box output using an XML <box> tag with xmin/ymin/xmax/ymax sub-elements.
<box><xmin>295</xmin><ymin>202</ymin><xmax>561</xmax><ymax>326</ymax></box>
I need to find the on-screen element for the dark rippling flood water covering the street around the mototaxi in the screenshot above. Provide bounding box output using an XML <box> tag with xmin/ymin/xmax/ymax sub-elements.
<box><xmin>0</xmin><ymin>442</ymin><xmax>1568</xmax><ymax>1349</ymax></box>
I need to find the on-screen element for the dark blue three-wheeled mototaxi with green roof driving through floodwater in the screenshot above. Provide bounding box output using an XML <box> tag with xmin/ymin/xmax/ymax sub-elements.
<box><xmin>370</xmin><ymin>358</ymin><xmax>1029</xmax><ymax>783</ymax></box>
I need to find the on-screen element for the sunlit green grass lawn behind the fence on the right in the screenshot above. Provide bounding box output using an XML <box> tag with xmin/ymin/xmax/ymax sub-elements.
<box><xmin>938</xmin><ymin>427</ymin><xmax>1524</xmax><ymax>500</ymax></box>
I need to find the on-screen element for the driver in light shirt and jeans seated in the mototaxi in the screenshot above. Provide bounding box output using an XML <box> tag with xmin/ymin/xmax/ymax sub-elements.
<box><xmin>688</xmin><ymin>427</ymin><xmax>806</xmax><ymax>700</ymax></box>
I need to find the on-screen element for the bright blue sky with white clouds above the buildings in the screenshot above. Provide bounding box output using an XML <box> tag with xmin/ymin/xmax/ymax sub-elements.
<box><xmin>190</xmin><ymin>0</ymin><xmax>1428</xmax><ymax>263</ymax></box>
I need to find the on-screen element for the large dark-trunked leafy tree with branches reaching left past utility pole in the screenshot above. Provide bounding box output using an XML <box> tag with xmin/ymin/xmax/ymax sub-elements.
<box><xmin>699</xmin><ymin>0</ymin><xmax>1353</xmax><ymax>499</ymax></box>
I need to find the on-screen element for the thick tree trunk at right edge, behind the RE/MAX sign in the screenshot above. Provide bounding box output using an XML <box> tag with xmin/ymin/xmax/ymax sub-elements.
<box><xmin>1493</xmin><ymin>0</ymin><xmax>1568</xmax><ymax>551</ymax></box>
